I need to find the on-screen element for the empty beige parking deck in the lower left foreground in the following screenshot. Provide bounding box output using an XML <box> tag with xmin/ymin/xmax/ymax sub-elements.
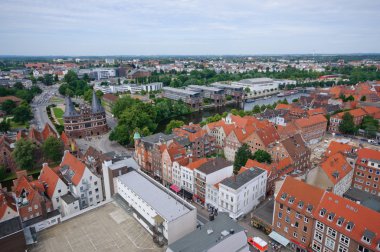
<box><xmin>30</xmin><ymin>202</ymin><xmax>164</xmax><ymax>252</ymax></box>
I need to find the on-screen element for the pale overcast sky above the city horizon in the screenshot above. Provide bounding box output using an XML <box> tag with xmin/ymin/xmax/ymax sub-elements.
<box><xmin>0</xmin><ymin>0</ymin><xmax>380</xmax><ymax>56</ymax></box>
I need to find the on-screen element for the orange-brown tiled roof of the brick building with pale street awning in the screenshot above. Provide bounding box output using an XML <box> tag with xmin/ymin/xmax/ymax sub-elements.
<box><xmin>276</xmin><ymin>176</ymin><xmax>324</xmax><ymax>216</ymax></box>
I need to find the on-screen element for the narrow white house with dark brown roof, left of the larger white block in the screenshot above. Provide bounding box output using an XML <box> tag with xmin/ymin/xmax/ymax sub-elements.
<box><xmin>194</xmin><ymin>157</ymin><xmax>233</xmax><ymax>207</ymax></box>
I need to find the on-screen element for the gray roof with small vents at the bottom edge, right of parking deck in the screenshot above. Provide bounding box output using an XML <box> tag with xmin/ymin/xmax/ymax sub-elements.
<box><xmin>166</xmin><ymin>213</ymin><xmax>247</xmax><ymax>252</ymax></box>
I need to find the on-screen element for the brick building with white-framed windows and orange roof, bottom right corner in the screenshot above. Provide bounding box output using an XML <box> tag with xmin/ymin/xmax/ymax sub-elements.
<box><xmin>311</xmin><ymin>192</ymin><xmax>380</xmax><ymax>252</ymax></box>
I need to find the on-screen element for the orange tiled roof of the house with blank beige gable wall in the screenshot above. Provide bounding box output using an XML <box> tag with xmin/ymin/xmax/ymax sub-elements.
<box><xmin>321</xmin><ymin>152</ymin><xmax>352</xmax><ymax>184</ymax></box>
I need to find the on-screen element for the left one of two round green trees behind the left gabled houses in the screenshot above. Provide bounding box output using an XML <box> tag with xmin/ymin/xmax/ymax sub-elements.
<box><xmin>12</xmin><ymin>138</ymin><xmax>37</xmax><ymax>170</ymax></box>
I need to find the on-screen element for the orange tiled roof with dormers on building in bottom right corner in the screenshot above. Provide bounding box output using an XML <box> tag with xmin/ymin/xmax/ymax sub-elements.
<box><xmin>314</xmin><ymin>192</ymin><xmax>380</xmax><ymax>251</ymax></box>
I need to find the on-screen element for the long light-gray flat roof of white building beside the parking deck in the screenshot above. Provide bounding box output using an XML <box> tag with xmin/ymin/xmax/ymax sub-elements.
<box><xmin>117</xmin><ymin>171</ymin><xmax>193</xmax><ymax>221</ymax></box>
